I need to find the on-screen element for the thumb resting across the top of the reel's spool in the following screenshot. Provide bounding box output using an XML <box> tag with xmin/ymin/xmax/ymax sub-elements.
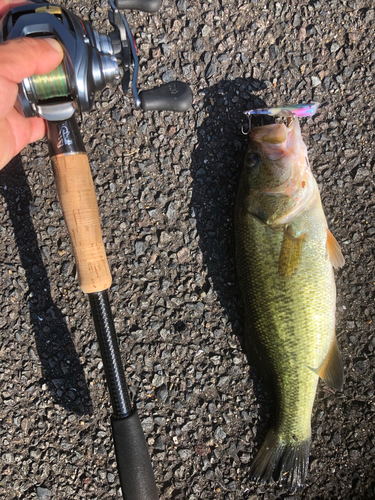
<box><xmin>0</xmin><ymin>37</ymin><xmax>63</xmax><ymax>83</ymax></box>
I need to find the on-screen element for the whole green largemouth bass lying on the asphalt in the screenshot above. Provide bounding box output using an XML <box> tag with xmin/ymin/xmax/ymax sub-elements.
<box><xmin>235</xmin><ymin>110</ymin><xmax>344</xmax><ymax>491</ymax></box>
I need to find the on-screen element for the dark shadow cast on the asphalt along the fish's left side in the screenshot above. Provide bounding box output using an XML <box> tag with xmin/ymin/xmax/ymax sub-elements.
<box><xmin>191</xmin><ymin>78</ymin><xmax>273</xmax><ymax>464</ymax></box>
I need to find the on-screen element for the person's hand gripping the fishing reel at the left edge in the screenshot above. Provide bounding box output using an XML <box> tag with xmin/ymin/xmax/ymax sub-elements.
<box><xmin>0</xmin><ymin>0</ymin><xmax>63</xmax><ymax>169</ymax></box>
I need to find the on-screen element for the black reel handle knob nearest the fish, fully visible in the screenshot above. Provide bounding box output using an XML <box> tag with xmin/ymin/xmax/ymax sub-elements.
<box><xmin>139</xmin><ymin>82</ymin><xmax>193</xmax><ymax>111</ymax></box>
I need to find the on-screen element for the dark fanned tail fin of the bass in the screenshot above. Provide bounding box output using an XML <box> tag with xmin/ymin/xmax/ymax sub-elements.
<box><xmin>249</xmin><ymin>429</ymin><xmax>311</xmax><ymax>491</ymax></box>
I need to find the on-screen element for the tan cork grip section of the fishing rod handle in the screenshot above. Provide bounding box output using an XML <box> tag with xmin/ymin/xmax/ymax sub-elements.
<box><xmin>51</xmin><ymin>153</ymin><xmax>112</xmax><ymax>293</ymax></box>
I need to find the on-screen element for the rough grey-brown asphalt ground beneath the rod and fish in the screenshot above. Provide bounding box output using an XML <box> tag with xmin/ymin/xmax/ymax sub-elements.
<box><xmin>0</xmin><ymin>0</ymin><xmax>375</xmax><ymax>500</ymax></box>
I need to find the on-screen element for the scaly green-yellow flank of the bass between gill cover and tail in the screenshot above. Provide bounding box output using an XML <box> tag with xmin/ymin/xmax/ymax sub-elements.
<box><xmin>236</xmin><ymin>203</ymin><xmax>335</xmax><ymax>434</ymax></box>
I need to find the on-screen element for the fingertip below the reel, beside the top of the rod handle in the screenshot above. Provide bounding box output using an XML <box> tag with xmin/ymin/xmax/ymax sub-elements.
<box><xmin>0</xmin><ymin>108</ymin><xmax>46</xmax><ymax>169</ymax></box>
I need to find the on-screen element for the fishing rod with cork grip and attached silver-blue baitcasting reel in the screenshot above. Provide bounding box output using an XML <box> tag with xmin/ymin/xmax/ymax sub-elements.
<box><xmin>0</xmin><ymin>0</ymin><xmax>192</xmax><ymax>500</ymax></box>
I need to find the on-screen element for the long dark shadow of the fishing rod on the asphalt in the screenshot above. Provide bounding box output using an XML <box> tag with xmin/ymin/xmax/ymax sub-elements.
<box><xmin>0</xmin><ymin>156</ymin><xmax>93</xmax><ymax>415</ymax></box>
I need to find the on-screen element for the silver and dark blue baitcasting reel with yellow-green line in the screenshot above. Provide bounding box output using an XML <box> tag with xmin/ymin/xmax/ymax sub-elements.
<box><xmin>0</xmin><ymin>0</ymin><xmax>192</xmax><ymax>121</ymax></box>
